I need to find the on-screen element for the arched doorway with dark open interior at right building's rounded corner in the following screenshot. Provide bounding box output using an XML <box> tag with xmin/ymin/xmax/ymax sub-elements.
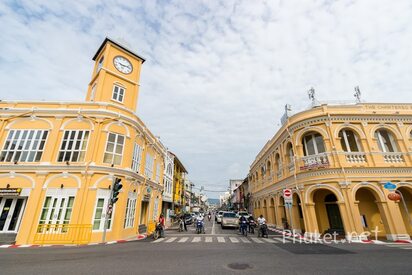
<box><xmin>313</xmin><ymin>189</ymin><xmax>345</xmax><ymax>236</ymax></box>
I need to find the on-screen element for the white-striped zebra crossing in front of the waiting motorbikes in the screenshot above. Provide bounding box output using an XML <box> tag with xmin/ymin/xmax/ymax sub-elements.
<box><xmin>151</xmin><ymin>236</ymin><xmax>292</xmax><ymax>244</ymax></box>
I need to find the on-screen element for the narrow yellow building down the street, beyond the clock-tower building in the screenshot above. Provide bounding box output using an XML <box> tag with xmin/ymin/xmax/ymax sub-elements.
<box><xmin>172</xmin><ymin>154</ymin><xmax>187</xmax><ymax>214</ymax></box>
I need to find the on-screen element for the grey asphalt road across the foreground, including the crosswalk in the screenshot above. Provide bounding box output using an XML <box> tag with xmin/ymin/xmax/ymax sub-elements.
<box><xmin>0</xmin><ymin>219</ymin><xmax>412</xmax><ymax>274</ymax></box>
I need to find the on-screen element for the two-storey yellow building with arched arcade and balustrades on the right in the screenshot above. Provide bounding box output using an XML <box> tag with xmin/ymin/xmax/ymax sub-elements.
<box><xmin>249</xmin><ymin>103</ymin><xmax>412</xmax><ymax>240</ymax></box>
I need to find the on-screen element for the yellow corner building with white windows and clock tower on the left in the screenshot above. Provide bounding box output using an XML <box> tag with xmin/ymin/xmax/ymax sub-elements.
<box><xmin>0</xmin><ymin>38</ymin><xmax>165</xmax><ymax>244</ymax></box>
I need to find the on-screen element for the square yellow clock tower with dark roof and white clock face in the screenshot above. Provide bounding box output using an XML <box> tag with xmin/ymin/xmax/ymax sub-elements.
<box><xmin>86</xmin><ymin>37</ymin><xmax>145</xmax><ymax>112</ymax></box>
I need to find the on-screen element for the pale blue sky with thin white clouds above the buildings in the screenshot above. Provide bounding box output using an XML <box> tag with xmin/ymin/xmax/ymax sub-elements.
<box><xmin>0</xmin><ymin>0</ymin><xmax>412</xmax><ymax>198</ymax></box>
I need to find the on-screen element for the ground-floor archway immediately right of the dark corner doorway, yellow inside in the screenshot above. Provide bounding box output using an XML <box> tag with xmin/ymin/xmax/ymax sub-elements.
<box><xmin>355</xmin><ymin>187</ymin><xmax>387</xmax><ymax>238</ymax></box>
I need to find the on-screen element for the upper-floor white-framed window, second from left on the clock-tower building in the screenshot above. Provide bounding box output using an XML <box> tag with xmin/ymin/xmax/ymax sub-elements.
<box><xmin>57</xmin><ymin>130</ymin><xmax>90</xmax><ymax>162</ymax></box>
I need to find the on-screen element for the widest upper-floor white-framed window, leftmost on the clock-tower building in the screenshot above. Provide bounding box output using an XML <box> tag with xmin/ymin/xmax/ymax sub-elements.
<box><xmin>0</xmin><ymin>129</ymin><xmax>49</xmax><ymax>162</ymax></box>
